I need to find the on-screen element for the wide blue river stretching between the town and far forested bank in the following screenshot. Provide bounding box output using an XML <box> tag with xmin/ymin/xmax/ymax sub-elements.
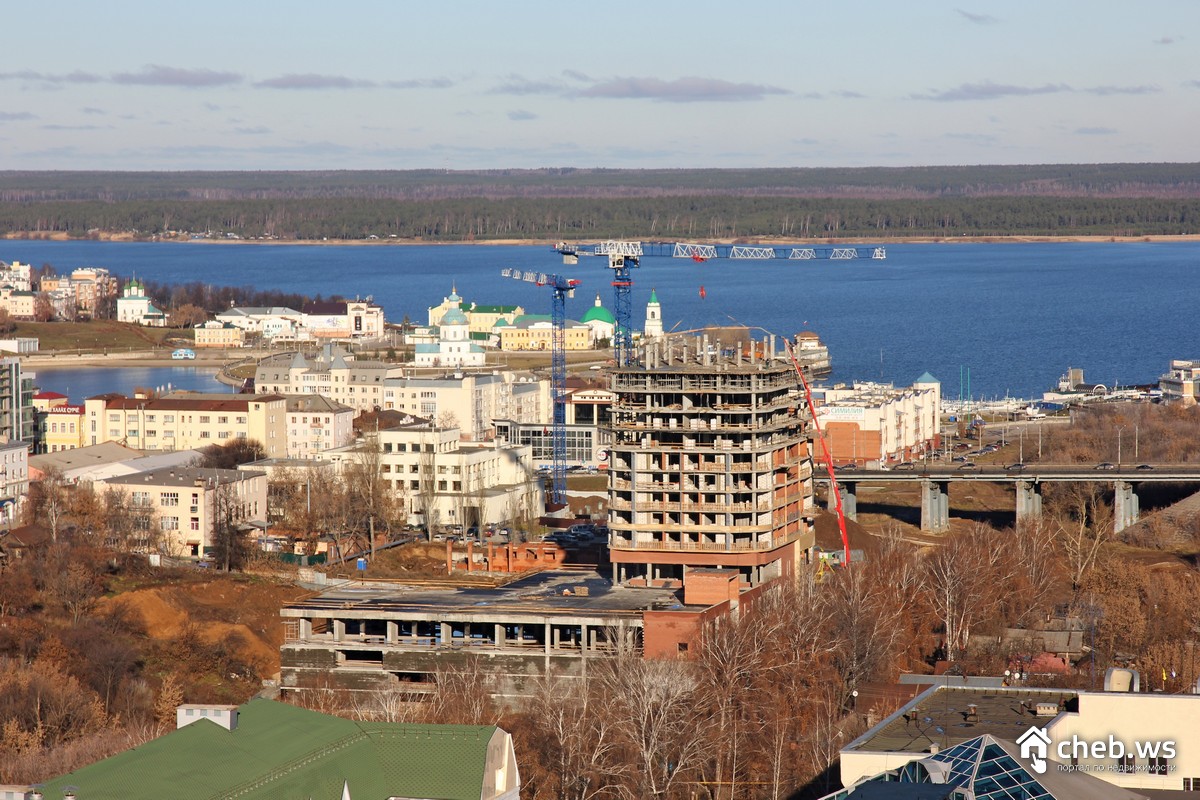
<box><xmin>0</xmin><ymin>241</ymin><xmax>1200</xmax><ymax>398</ymax></box>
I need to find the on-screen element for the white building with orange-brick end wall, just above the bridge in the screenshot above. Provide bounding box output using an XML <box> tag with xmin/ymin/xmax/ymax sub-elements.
<box><xmin>815</xmin><ymin>372</ymin><xmax>942</xmax><ymax>464</ymax></box>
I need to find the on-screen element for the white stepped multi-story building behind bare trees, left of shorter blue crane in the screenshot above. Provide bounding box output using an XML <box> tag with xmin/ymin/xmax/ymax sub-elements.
<box><xmin>323</xmin><ymin>422</ymin><xmax>544</xmax><ymax>525</ymax></box>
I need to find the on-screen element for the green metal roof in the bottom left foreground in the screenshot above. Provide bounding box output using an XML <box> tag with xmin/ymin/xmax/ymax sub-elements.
<box><xmin>42</xmin><ymin>699</ymin><xmax>496</xmax><ymax>800</ymax></box>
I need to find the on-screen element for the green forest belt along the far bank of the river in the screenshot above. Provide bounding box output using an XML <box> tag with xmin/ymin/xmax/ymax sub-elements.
<box><xmin>0</xmin><ymin>194</ymin><xmax>1200</xmax><ymax>242</ymax></box>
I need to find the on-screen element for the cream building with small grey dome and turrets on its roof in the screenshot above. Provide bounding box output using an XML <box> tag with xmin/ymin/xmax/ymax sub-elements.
<box><xmin>254</xmin><ymin>344</ymin><xmax>403</xmax><ymax>411</ymax></box>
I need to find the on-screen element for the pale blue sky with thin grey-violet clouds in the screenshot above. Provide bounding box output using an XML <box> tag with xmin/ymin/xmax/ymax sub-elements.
<box><xmin>0</xmin><ymin>0</ymin><xmax>1200</xmax><ymax>170</ymax></box>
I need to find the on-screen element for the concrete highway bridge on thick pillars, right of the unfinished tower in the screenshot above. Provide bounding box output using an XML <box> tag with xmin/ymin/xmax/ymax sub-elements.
<box><xmin>816</xmin><ymin>463</ymin><xmax>1200</xmax><ymax>533</ymax></box>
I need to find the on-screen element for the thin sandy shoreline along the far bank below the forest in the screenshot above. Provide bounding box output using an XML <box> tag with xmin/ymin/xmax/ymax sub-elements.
<box><xmin>9</xmin><ymin>233</ymin><xmax>1200</xmax><ymax>247</ymax></box>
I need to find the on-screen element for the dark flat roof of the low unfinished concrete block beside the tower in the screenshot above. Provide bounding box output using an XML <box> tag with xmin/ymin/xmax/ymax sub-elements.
<box><xmin>282</xmin><ymin>568</ymin><xmax>696</xmax><ymax>616</ymax></box>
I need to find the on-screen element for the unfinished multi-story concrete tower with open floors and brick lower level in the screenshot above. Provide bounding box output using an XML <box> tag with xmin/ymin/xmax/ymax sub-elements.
<box><xmin>608</xmin><ymin>335</ymin><xmax>815</xmax><ymax>588</ymax></box>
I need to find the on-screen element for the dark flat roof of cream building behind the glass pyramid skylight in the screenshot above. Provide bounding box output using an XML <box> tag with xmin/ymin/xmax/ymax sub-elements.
<box><xmin>846</xmin><ymin>686</ymin><xmax>1079</xmax><ymax>753</ymax></box>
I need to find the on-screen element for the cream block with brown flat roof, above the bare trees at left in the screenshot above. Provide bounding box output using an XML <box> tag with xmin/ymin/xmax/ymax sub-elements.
<box><xmin>100</xmin><ymin>467</ymin><xmax>266</xmax><ymax>557</ymax></box>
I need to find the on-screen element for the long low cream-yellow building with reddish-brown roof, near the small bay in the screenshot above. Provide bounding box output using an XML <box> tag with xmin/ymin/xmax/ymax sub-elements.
<box><xmin>84</xmin><ymin>392</ymin><xmax>288</xmax><ymax>458</ymax></box>
